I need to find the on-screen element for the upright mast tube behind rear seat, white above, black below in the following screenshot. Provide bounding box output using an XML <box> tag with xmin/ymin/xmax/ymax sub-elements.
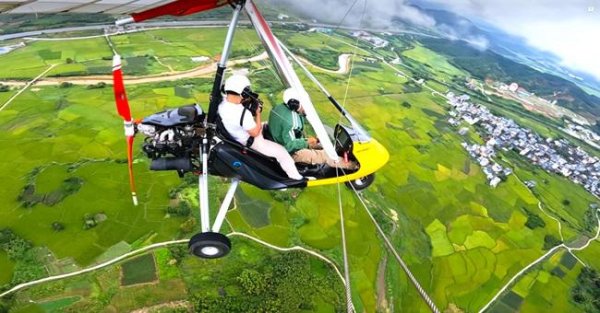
<box><xmin>207</xmin><ymin>4</ymin><xmax>243</xmax><ymax>124</ymax></box>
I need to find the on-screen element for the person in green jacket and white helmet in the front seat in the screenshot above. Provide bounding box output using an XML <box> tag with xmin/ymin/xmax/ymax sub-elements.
<box><xmin>269</xmin><ymin>88</ymin><xmax>358</xmax><ymax>169</ymax></box>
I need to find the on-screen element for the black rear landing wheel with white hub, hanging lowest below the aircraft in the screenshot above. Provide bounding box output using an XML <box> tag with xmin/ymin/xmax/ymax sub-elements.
<box><xmin>188</xmin><ymin>232</ymin><xmax>231</xmax><ymax>259</ymax></box>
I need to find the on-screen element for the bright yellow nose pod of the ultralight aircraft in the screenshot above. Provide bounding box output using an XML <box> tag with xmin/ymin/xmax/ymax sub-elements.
<box><xmin>306</xmin><ymin>139</ymin><xmax>390</xmax><ymax>187</ymax></box>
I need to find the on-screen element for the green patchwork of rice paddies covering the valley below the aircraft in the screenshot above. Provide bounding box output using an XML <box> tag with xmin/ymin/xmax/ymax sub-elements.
<box><xmin>0</xmin><ymin>24</ymin><xmax>600</xmax><ymax>312</ymax></box>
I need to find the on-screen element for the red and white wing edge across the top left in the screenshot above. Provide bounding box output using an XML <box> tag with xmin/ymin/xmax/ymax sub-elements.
<box><xmin>0</xmin><ymin>0</ymin><xmax>228</xmax><ymax>17</ymax></box>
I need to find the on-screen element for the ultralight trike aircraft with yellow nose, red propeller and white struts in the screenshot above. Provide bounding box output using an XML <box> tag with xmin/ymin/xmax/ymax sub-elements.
<box><xmin>0</xmin><ymin>0</ymin><xmax>389</xmax><ymax>258</ymax></box>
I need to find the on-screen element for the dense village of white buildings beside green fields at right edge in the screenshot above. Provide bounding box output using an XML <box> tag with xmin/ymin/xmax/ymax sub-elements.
<box><xmin>446</xmin><ymin>92</ymin><xmax>600</xmax><ymax>196</ymax></box>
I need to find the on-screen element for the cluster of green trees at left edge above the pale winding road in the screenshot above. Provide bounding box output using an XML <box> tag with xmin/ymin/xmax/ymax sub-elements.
<box><xmin>0</xmin><ymin>228</ymin><xmax>46</xmax><ymax>289</ymax></box>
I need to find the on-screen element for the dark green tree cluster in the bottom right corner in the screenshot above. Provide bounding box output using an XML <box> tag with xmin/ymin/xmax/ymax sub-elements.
<box><xmin>571</xmin><ymin>267</ymin><xmax>600</xmax><ymax>313</ymax></box>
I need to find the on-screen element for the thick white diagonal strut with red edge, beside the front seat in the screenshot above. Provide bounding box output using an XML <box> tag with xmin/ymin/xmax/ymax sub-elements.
<box><xmin>245</xmin><ymin>1</ymin><xmax>338</xmax><ymax>160</ymax></box>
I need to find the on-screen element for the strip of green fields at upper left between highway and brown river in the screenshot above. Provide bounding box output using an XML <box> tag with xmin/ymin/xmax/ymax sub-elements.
<box><xmin>0</xmin><ymin>28</ymin><xmax>258</xmax><ymax>80</ymax></box>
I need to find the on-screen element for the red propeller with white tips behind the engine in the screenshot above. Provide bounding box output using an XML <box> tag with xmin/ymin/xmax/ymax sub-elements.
<box><xmin>113</xmin><ymin>54</ymin><xmax>138</xmax><ymax>205</ymax></box>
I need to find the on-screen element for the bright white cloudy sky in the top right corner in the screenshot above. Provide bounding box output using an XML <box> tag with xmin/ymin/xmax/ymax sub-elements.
<box><xmin>430</xmin><ymin>0</ymin><xmax>600</xmax><ymax>79</ymax></box>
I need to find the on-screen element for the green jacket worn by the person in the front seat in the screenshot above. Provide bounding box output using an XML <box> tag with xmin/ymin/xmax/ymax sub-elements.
<box><xmin>269</xmin><ymin>103</ymin><xmax>308</xmax><ymax>153</ymax></box>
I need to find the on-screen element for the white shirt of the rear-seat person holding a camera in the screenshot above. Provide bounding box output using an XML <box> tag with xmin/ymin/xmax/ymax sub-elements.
<box><xmin>219</xmin><ymin>100</ymin><xmax>256</xmax><ymax>145</ymax></box>
